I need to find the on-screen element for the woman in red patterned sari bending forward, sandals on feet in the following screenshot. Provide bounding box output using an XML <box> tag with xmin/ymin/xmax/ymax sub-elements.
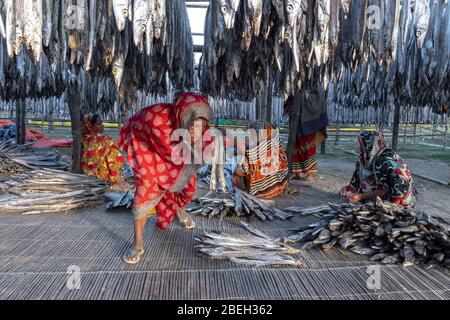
<box><xmin>119</xmin><ymin>92</ymin><xmax>212</xmax><ymax>264</ymax></box>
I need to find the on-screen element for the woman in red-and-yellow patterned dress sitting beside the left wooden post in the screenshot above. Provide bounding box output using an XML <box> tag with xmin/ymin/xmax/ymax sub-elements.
<box><xmin>81</xmin><ymin>114</ymin><xmax>124</xmax><ymax>187</ymax></box>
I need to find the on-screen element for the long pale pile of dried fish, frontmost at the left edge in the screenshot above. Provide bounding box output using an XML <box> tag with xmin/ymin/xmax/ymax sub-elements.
<box><xmin>0</xmin><ymin>169</ymin><xmax>106</xmax><ymax>214</ymax></box>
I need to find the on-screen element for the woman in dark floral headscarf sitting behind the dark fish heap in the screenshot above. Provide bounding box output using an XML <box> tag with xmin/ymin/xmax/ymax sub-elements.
<box><xmin>340</xmin><ymin>131</ymin><xmax>417</xmax><ymax>207</ymax></box>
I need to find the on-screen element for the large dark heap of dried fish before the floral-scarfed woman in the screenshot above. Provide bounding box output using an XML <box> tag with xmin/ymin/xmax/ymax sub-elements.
<box><xmin>282</xmin><ymin>198</ymin><xmax>450</xmax><ymax>267</ymax></box>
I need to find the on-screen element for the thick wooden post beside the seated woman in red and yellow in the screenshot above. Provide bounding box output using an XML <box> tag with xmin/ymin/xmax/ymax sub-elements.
<box><xmin>67</xmin><ymin>85</ymin><xmax>82</xmax><ymax>173</ymax></box>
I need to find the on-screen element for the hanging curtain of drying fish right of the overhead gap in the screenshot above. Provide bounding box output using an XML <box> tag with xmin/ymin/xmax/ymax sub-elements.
<box><xmin>200</xmin><ymin>0</ymin><xmax>450</xmax><ymax>107</ymax></box>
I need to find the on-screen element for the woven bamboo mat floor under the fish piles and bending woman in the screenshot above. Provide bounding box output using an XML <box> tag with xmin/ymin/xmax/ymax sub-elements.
<box><xmin>0</xmin><ymin>165</ymin><xmax>450</xmax><ymax>300</ymax></box>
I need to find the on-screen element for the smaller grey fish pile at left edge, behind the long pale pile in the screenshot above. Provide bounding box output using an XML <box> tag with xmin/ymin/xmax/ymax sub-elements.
<box><xmin>0</xmin><ymin>140</ymin><xmax>70</xmax><ymax>173</ymax></box>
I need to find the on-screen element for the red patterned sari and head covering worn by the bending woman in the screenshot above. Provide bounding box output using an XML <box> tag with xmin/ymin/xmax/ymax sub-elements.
<box><xmin>119</xmin><ymin>92</ymin><xmax>212</xmax><ymax>229</ymax></box>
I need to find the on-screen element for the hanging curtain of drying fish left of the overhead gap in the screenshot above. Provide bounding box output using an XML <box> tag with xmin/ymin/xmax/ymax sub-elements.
<box><xmin>0</xmin><ymin>0</ymin><xmax>194</xmax><ymax>104</ymax></box>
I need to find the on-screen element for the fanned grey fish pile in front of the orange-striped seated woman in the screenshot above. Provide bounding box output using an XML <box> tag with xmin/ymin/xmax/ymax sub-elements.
<box><xmin>186</xmin><ymin>188</ymin><xmax>292</xmax><ymax>221</ymax></box>
